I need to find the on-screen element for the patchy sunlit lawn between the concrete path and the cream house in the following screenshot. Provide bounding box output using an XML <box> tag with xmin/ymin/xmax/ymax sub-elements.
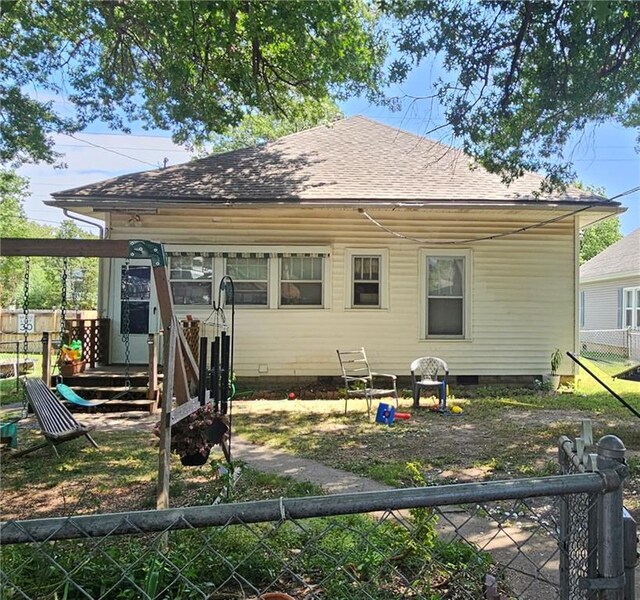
<box><xmin>234</xmin><ymin>378</ymin><xmax>640</xmax><ymax>494</ymax></box>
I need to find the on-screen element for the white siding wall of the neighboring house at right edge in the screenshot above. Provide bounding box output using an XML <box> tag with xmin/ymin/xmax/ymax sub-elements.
<box><xmin>580</xmin><ymin>276</ymin><xmax>640</xmax><ymax>330</ymax></box>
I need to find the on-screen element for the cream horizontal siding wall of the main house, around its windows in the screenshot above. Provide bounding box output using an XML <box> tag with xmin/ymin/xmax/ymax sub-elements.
<box><xmin>105</xmin><ymin>207</ymin><xmax>577</xmax><ymax>376</ymax></box>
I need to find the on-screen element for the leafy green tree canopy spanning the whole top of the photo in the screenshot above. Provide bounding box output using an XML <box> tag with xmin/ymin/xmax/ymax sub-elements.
<box><xmin>0</xmin><ymin>0</ymin><xmax>640</xmax><ymax>188</ymax></box>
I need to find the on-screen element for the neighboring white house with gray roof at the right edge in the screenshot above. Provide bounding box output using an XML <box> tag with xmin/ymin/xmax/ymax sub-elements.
<box><xmin>580</xmin><ymin>228</ymin><xmax>640</xmax><ymax>330</ymax></box>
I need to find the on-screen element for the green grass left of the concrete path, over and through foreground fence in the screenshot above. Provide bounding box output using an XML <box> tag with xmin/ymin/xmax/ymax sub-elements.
<box><xmin>0</xmin><ymin>422</ymin><xmax>500</xmax><ymax>600</ymax></box>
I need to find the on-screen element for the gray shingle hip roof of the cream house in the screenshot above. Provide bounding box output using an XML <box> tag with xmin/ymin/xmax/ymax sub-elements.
<box><xmin>51</xmin><ymin>116</ymin><xmax>602</xmax><ymax>204</ymax></box>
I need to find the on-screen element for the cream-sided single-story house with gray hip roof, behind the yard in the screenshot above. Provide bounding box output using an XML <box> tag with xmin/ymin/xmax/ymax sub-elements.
<box><xmin>48</xmin><ymin>117</ymin><xmax>624</xmax><ymax>383</ymax></box>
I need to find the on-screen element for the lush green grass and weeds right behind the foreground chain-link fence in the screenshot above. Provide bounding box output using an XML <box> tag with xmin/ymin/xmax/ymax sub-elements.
<box><xmin>2</xmin><ymin>486</ymin><xmax>492</xmax><ymax>600</ymax></box>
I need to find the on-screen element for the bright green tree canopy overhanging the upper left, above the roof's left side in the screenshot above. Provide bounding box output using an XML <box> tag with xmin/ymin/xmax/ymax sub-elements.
<box><xmin>0</xmin><ymin>0</ymin><xmax>386</xmax><ymax>164</ymax></box>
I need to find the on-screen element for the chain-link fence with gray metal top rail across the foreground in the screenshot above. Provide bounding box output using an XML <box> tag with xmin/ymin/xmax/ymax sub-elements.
<box><xmin>0</xmin><ymin>420</ymin><xmax>635</xmax><ymax>600</ymax></box>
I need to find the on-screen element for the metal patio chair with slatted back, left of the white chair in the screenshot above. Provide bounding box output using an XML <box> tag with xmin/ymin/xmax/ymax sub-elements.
<box><xmin>336</xmin><ymin>348</ymin><xmax>398</xmax><ymax>416</ymax></box>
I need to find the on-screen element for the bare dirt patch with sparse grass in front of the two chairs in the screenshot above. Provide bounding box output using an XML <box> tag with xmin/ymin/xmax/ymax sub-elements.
<box><xmin>234</xmin><ymin>399</ymin><xmax>640</xmax><ymax>517</ymax></box>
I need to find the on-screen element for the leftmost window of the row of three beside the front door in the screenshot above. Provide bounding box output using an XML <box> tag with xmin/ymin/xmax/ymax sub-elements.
<box><xmin>169</xmin><ymin>255</ymin><xmax>213</xmax><ymax>306</ymax></box>
